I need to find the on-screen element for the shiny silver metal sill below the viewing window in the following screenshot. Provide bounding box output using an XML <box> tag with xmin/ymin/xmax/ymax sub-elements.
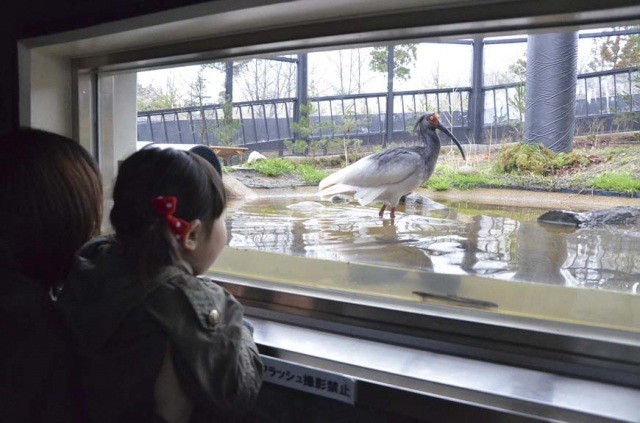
<box><xmin>248</xmin><ymin>317</ymin><xmax>640</xmax><ymax>423</ymax></box>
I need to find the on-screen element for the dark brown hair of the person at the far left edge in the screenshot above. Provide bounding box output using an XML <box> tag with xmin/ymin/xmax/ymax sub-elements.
<box><xmin>0</xmin><ymin>128</ymin><xmax>103</xmax><ymax>289</ymax></box>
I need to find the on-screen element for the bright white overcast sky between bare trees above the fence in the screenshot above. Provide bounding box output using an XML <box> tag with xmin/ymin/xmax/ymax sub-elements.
<box><xmin>138</xmin><ymin>29</ymin><xmax>620</xmax><ymax>103</ymax></box>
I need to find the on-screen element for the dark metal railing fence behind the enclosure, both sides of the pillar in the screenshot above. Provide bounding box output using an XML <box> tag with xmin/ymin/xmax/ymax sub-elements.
<box><xmin>138</xmin><ymin>68</ymin><xmax>640</xmax><ymax>151</ymax></box>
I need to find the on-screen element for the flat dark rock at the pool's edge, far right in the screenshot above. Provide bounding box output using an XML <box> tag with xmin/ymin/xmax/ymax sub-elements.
<box><xmin>538</xmin><ymin>206</ymin><xmax>640</xmax><ymax>227</ymax></box>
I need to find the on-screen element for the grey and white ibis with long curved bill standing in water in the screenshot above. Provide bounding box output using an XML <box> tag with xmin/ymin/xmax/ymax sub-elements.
<box><xmin>317</xmin><ymin>112</ymin><xmax>466</xmax><ymax>219</ymax></box>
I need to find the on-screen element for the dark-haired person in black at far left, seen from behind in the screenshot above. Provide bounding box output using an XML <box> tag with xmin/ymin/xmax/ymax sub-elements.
<box><xmin>0</xmin><ymin>128</ymin><xmax>103</xmax><ymax>422</ymax></box>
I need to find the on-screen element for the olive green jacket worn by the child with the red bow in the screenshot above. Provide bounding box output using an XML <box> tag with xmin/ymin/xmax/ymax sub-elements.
<box><xmin>58</xmin><ymin>237</ymin><xmax>263</xmax><ymax>422</ymax></box>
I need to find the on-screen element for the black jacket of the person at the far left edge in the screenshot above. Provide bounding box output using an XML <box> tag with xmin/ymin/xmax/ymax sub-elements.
<box><xmin>0</xmin><ymin>254</ymin><xmax>84</xmax><ymax>422</ymax></box>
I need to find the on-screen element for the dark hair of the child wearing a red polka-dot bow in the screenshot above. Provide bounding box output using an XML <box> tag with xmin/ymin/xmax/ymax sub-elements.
<box><xmin>110</xmin><ymin>146</ymin><xmax>226</xmax><ymax>279</ymax></box>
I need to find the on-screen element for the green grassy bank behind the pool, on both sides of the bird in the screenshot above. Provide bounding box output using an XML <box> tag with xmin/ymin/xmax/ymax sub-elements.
<box><xmin>249</xmin><ymin>144</ymin><xmax>640</xmax><ymax>195</ymax></box>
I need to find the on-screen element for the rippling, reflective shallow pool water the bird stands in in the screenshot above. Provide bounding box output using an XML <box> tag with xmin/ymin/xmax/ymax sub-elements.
<box><xmin>227</xmin><ymin>197</ymin><xmax>640</xmax><ymax>293</ymax></box>
